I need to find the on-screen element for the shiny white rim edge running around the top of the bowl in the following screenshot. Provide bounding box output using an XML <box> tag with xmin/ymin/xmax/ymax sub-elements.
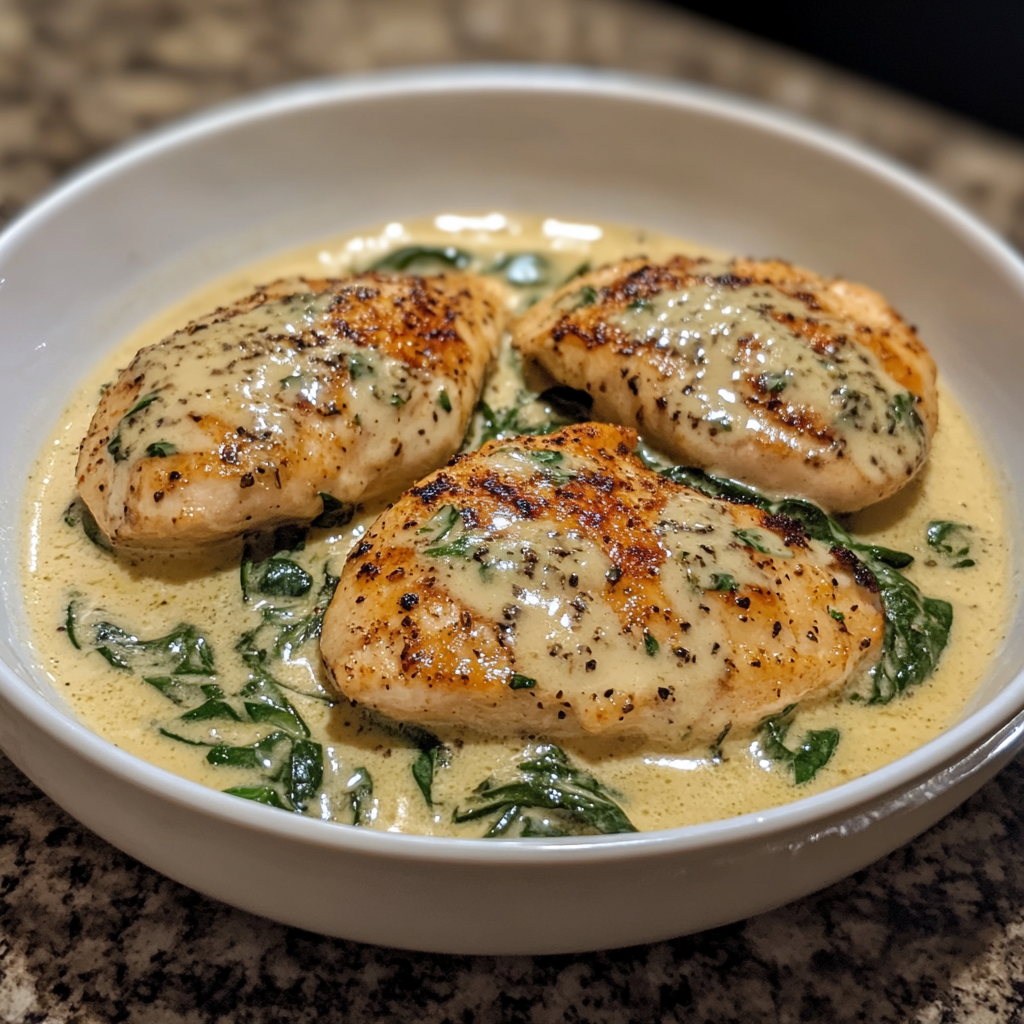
<box><xmin>0</xmin><ymin>63</ymin><xmax>1024</xmax><ymax>865</ymax></box>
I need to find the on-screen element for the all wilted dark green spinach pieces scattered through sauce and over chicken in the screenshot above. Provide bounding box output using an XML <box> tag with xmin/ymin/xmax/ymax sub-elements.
<box><xmin>58</xmin><ymin>246</ymin><xmax>958</xmax><ymax>838</ymax></box>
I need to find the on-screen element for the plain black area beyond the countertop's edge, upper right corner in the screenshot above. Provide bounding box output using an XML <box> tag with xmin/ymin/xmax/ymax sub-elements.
<box><xmin>670</xmin><ymin>0</ymin><xmax>1024</xmax><ymax>138</ymax></box>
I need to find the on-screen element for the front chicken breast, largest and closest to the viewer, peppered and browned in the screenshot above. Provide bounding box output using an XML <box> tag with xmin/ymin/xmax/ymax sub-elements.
<box><xmin>321</xmin><ymin>423</ymin><xmax>883</xmax><ymax>749</ymax></box>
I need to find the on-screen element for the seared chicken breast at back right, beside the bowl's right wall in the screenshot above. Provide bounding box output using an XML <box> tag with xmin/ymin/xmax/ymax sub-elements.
<box><xmin>513</xmin><ymin>256</ymin><xmax>938</xmax><ymax>511</ymax></box>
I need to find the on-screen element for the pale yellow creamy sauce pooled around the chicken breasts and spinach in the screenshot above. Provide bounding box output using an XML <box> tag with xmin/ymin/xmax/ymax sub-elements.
<box><xmin>23</xmin><ymin>214</ymin><xmax>1010</xmax><ymax>837</ymax></box>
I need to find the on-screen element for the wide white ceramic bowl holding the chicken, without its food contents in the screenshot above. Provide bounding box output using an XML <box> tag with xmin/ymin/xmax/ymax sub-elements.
<box><xmin>0</xmin><ymin>68</ymin><xmax>1024</xmax><ymax>953</ymax></box>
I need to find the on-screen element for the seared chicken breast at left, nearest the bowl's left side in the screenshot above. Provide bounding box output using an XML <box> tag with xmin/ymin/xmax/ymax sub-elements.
<box><xmin>78</xmin><ymin>273</ymin><xmax>503</xmax><ymax>548</ymax></box>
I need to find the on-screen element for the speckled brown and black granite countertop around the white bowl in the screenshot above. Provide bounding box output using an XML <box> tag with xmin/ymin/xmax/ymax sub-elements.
<box><xmin>0</xmin><ymin>0</ymin><xmax>1024</xmax><ymax>1024</ymax></box>
